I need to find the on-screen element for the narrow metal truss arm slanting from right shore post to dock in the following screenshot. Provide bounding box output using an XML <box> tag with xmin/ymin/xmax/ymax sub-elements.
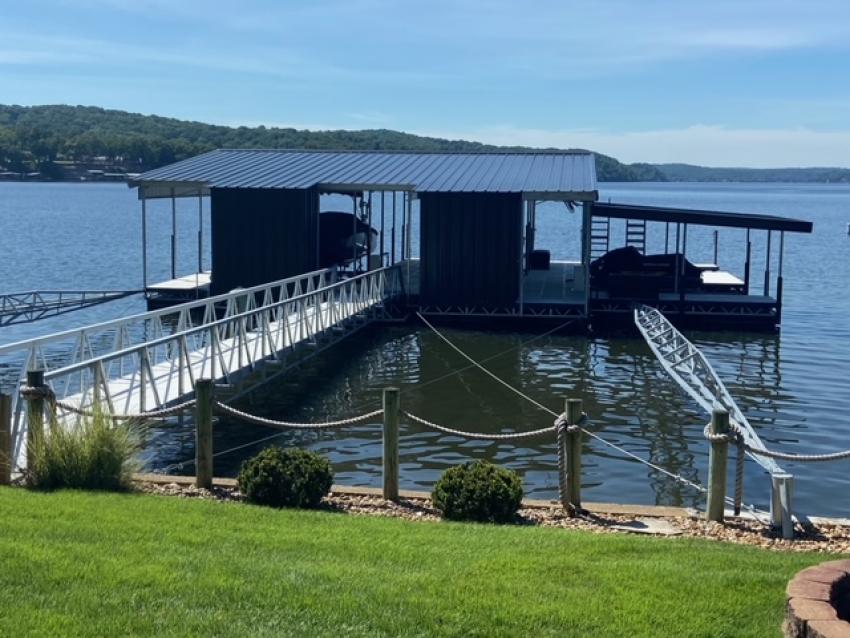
<box><xmin>634</xmin><ymin>304</ymin><xmax>793</xmax><ymax>527</ymax></box>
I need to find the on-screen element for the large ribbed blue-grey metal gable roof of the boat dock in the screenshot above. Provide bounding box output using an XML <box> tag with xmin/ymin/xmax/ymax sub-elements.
<box><xmin>129</xmin><ymin>149</ymin><xmax>598</xmax><ymax>201</ymax></box>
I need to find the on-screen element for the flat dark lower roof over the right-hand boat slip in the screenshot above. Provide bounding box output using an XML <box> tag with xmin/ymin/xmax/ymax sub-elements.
<box><xmin>593</xmin><ymin>204</ymin><xmax>812</xmax><ymax>233</ymax></box>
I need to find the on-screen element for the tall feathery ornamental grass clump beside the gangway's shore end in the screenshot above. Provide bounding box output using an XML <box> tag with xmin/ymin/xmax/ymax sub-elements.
<box><xmin>26</xmin><ymin>410</ymin><xmax>139</xmax><ymax>491</ymax></box>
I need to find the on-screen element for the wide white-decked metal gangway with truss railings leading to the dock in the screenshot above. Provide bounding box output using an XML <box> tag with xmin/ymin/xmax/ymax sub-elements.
<box><xmin>0</xmin><ymin>265</ymin><xmax>402</xmax><ymax>467</ymax></box>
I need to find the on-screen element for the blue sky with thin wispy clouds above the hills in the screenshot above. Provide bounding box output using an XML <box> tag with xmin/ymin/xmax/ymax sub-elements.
<box><xmin>0</xmin><ymin>0</ymin><xmax>850</xmax><ymax>167</ymax></box>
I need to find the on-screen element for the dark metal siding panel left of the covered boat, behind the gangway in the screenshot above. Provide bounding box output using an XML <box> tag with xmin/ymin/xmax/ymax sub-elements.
<box><xmin>210</xmin><ymin>188</ymin><xmax>319</xmax><ymax>294</ymax></box>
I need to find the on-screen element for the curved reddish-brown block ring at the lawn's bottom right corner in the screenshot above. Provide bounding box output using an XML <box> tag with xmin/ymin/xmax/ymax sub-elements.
<box><xmin>784</xmin><ymin>560</ymin><xmax>850</xmax><ymax>638</ymax></box>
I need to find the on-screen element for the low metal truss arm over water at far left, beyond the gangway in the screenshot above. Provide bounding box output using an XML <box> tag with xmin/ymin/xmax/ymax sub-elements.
<box><xmin>0</xmin><ymin>290</ymin><xmax>142</xmax><ymax>326</ymax></box>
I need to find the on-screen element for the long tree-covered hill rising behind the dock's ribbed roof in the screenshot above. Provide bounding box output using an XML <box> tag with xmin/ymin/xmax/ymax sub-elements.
<box><xmin>0</xmin><ymin>105</ymin><xmax>665</xmax><ymax>182</ymax></box>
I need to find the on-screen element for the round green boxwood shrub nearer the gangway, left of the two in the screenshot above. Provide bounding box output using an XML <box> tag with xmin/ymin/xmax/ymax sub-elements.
<box><xmin>237</xmin><ymin>446</ymin><xmax>333</xmax><ymax>507</ymax></box>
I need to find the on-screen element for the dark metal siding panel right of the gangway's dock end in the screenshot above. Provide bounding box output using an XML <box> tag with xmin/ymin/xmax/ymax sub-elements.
<box><xmin>420</xmin><ymin>193</ymin><xmax>522</xmax><ymax>307</ymax></box>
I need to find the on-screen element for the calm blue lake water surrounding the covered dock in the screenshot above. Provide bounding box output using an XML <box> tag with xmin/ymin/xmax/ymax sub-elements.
<box><xmin>0</xmin><ymin>183</ymin><xmax>850</xmax><ymax>515</ymax></box>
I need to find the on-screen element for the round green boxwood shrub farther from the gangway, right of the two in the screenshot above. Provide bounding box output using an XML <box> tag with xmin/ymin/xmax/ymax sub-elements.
<box><xmin>431</xmin><ymin>461</ymin><xmax>522</xmax><ymax>523</ymax></box>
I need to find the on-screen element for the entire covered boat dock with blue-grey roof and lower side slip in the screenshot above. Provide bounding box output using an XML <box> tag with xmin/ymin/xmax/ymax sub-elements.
<box><xmin>130</xmin><ymin>150</ymin><xmax>812</xmax><ymax>328</ymax></box>
